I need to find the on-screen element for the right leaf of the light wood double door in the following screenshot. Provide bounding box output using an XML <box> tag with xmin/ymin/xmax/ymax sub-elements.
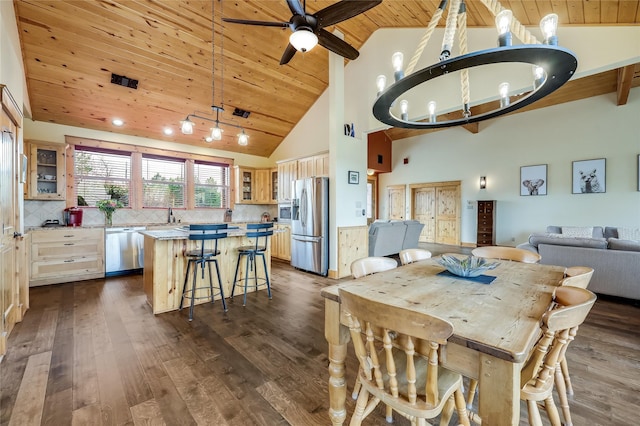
<box><xmin>436</xmin><ymin>185</ymin><xmax>460</xmax><ymax>245</ymax></box>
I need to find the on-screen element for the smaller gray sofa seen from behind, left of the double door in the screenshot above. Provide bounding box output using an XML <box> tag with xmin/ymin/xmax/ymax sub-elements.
<box><xmin>369</xmin><ymin>220</ymin><xmax>424</xmax><ymax>256</ymax></box>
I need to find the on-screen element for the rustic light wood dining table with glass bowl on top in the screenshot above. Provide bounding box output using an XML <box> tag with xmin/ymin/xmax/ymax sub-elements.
<box><xmin>322</xmin><ymin>258</ymin><xmax>564</xmax><ymax>426</ymax></box>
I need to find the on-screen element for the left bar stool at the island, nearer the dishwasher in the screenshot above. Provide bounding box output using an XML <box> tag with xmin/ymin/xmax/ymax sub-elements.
<box><xmin>179</xmin><ymin>223</ymin><xmax>228</xmax><ymax>321</ymax></box>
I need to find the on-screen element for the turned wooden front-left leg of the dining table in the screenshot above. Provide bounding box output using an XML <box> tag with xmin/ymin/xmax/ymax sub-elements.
<box><xmin>324</xmin><ymin>299</ymin><xmax>349</xmax><ymax>426</ymax></box>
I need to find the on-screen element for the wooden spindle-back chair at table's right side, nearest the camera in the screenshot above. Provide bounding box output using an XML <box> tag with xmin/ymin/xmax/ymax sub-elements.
<box><xmin>520</xmin><ymin>287</ymin><xmax>596</xmax><ymax>426</ymax></box>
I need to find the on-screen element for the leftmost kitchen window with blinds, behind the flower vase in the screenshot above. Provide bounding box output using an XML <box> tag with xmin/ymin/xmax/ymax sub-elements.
<box><xmin>74</xmin><ymin>146</ymin><xmax>131</xmax><ymax>207</ymax></box>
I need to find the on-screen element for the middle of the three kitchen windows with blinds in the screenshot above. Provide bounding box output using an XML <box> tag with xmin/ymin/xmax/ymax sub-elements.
<box><xmin>142</xmin><ymin>155</ymin><xmax>185</xmax><ymax>208</ymax></box>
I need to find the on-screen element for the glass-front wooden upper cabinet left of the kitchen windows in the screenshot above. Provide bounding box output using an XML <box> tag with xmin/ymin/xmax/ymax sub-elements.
<box><xmin>26</xmin><ymin>141</ymin><xmax>66</xmax><ymax>200</ymax></box>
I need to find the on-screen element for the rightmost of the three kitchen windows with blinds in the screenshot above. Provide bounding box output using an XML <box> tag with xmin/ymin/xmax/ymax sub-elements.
<box><xmin>193</xmin><ymin>161</ymin><xmax>230</xmax><ymax>208</ymax></box>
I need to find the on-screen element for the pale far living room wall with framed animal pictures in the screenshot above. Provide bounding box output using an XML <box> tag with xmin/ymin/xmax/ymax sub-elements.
<box><xmin>379</xmin><ymin>88</ymin><xmax>640</xmax><ymax>245</ymax></box>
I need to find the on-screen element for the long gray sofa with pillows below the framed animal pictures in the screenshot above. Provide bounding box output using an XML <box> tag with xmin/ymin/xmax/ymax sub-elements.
<box><xmin>518</xmin><ymin>226</ymin><xmax>640</xmax><ymax>300</ymax></box>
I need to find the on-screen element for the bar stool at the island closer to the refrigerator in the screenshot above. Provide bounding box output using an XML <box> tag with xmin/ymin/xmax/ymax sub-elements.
<box><xmin>231</xmin><ymin>222</ymin><xmax>273</xmax><ymax>306</ymax></box>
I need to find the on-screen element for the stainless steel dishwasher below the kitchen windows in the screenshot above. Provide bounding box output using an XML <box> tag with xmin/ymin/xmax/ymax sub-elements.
<box><xmin>104</xmin><ymin>226</ymin><xmax>147</xmax><ymax>277</ymax></box>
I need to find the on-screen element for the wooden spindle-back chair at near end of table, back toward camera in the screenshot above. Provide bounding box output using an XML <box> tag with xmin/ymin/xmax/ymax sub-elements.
<box><xmin>339</xmin><ymin>290</ymin><xmax>469</xmax><ymax>426</ymax></box>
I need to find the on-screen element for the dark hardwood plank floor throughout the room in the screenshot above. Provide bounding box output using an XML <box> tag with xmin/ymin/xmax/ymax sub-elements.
<box><xmin>0</xmin><ymin>246</ymin><xmax>640</xmax><ymax>426</ymax></box>
